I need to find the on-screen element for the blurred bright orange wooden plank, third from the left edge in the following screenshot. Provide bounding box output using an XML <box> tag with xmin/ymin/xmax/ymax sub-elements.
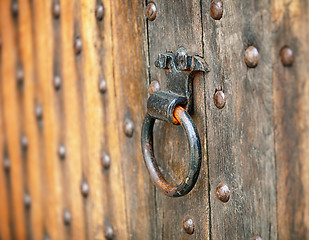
<box><xmin>31</xmin><ymin>1</ymin><xmax>65</xmax><ymax>239</ymax></box>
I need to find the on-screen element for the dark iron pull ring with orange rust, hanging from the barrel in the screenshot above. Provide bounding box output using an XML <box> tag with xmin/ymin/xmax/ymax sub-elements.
<box><xmin>142</xmin><ymin>106</ymin><xmax>202</xmax><ymax>197</ymax></box>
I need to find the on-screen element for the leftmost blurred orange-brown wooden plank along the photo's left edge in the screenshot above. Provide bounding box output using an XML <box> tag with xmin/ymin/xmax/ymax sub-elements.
<box><xmin>0</xmin><ymin>1</ymin><xmax>27</xmax><ymax>239</ymax></box>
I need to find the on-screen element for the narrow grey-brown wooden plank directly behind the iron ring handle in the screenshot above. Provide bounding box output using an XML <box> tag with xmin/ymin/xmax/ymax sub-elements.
<box><xmin>145</xmin><ymin>0</ymin><xmax>209</xmax><ymax>239</ymax></box>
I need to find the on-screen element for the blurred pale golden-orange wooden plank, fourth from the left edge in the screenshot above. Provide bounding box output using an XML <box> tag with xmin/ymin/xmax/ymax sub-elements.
<box><xmin>60</xmin><ymin>1</ymin><xmax>88</xmax><ymax>239</ymax></box>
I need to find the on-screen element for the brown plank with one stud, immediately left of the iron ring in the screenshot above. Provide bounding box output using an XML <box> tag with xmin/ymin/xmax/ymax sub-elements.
<box><xmin>106</xmin><ymin>0</ymin><xmax>155</xmax><ymax>239</ymax></box>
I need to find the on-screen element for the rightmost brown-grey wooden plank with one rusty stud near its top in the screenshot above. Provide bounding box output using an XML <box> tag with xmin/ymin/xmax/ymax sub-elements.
<box><xmin>271</xmin><ymin>0</ymin><xmax>309</xmax><ymax>239</ymax></box>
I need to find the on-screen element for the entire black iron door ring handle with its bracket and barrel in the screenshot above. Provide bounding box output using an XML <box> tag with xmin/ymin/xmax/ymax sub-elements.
<box><xmin>142</xmin><ymin>48</ymin><xmax>209</xmax><ymax>197</ymax></box>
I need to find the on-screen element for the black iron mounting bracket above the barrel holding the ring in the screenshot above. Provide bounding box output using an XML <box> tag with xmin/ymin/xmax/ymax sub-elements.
<box><xmin>155</xmin><ymin>47</ymin><xmax>209</xmax><ymax>112</ymax></box>
